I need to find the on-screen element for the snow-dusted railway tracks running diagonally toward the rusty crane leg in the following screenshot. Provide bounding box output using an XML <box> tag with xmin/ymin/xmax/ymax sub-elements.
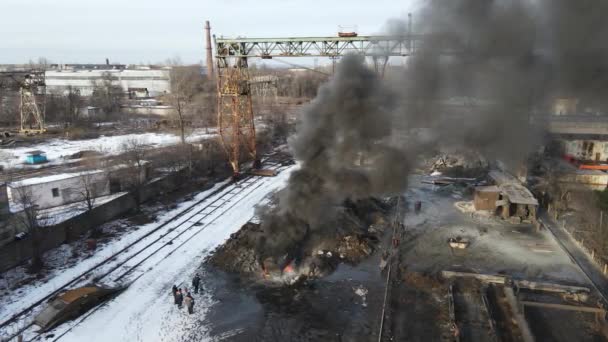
<box><xmin>0</xmin><ymin>157</ymin><xmax>291</xmax><ymax>341</ymax></box>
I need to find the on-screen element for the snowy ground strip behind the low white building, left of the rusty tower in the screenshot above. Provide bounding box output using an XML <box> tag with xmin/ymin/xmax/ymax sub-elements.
<box><xmin>0</xmin><ymin>129</ymin><xmax>216</xmax><ymax>168</ymax></box>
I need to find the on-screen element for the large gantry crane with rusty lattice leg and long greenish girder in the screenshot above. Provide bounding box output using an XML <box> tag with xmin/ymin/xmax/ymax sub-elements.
<box><xmin>213</xmin><ymin>19</ymin><xmax>422</xmax><ymax>176</ymax></box>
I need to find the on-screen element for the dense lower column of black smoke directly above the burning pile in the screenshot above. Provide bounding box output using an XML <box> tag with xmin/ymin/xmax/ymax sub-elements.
<box><xmin>261</xmin><ymin>56</ymin><xmax>410</xmax><ymax>255</ymax></box>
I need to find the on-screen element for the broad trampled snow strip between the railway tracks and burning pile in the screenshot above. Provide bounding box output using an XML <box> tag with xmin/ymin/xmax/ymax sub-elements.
<box><xmin>48</xmin><ymin>167</ymin><xmax>294</xmax><ymax>342</ymax></box>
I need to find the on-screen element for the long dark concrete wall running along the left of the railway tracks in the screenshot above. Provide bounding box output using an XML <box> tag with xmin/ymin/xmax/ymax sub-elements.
<box><xmin>0</xmin><ymin>170</ymin><xmax>192</xmax><ymax>272</ymax></box>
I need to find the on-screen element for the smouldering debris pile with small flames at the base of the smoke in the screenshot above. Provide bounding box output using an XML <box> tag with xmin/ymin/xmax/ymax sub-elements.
<box><xmin>210</xmin><ymin>198</ymin><xmax>392</xmax><ymax>283</ymax></box>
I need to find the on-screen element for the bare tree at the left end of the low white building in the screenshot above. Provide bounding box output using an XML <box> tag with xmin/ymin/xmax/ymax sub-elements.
<box><xmin>11</xmin><ymin>187</ymin><xmax>44</xmax><ymax>272</ymax></box>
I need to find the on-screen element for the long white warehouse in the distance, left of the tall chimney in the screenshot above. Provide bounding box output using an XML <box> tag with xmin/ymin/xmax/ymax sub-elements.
<box><xmin>45</xmin><ymin>64</ymin><xmax>171</xmax><ymax>97</ymax></box>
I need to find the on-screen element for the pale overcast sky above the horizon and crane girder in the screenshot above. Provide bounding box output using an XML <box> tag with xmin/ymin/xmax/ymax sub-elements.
<box><xmin>0</xmin><ymin>0</ymin><xmax>418</xmax><ymax>64</ymax></box>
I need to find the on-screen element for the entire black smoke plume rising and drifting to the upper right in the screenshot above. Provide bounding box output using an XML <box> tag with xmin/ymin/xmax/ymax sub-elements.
<box><xmin>259</xmin><ymin>0</ymin><xmax>608</xmax><ymax>262</ymax></box>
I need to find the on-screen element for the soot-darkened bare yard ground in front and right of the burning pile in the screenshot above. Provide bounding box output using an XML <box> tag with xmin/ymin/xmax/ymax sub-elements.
<box><xmin>185</xmin><ymin>176</ymin><xmax>604</xmax><ymax>341</ymax></box>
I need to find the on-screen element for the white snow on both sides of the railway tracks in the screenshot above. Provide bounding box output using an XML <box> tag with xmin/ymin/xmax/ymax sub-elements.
<box><xmin>0</xmin><ymin>167</ymin><xmax>293</xmax><ymax>341</ymax></box>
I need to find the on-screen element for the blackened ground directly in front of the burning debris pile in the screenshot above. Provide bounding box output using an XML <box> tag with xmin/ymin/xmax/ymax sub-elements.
<box><xmin>205</xmin><ymin>247</ymin><xmax>384</xmax><ymax>341</ymax></box>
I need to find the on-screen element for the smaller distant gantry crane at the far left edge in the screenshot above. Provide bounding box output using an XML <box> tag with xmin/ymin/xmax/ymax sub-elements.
<box><xmin>0</xmin><ymin>69</ymin><xmax>46</xmax><ymax>134</ymax></box>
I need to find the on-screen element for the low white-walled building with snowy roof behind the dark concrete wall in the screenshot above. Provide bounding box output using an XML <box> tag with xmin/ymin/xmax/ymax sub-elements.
<box><xmin>8</xmin><ymin>172</ymin><xmax>110</xmax><ymax>209</ymax></box>
